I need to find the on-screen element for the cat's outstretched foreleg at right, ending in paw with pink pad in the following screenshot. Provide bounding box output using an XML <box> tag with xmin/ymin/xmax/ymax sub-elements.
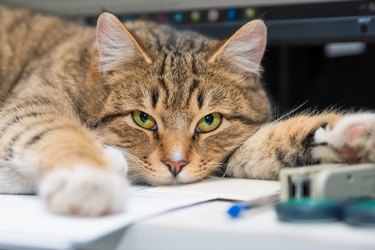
<box><xmin>227</xmin><ymin>113</ymin><xmax>375</xmax><ymax>179</ymax></box>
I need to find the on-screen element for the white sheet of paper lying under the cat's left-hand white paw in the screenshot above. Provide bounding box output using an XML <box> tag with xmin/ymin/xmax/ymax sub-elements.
<box><xmin>0</xmin><ymin>187</ymin><xmax>212</xmax><ymax>249</ymax></box>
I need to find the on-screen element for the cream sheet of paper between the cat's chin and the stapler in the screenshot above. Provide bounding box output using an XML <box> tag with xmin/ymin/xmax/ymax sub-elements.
<box><xmin>149</xmin><ymin>178</ymin><xmax>281</xmax><ymax>201</ymax></box>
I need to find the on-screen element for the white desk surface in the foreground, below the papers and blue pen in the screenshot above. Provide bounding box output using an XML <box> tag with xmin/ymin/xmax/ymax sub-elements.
<box><xmin>83</xmin><ymin>201</ymin><xmax>375</xmax><ymax>250</ymax></box>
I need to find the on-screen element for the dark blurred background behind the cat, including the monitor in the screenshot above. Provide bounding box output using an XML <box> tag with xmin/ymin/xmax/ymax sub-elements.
<box><xmin>0</xmin><ymin>0</ymin><xmax>375</xmax><ymax>116</ymax></box>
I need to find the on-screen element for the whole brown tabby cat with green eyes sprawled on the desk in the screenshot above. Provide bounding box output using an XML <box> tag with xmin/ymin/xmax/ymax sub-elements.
<box><xmin>0</xmin><ymin>6</ymin><xmax>375</xmax><ymax>216</ymax></box>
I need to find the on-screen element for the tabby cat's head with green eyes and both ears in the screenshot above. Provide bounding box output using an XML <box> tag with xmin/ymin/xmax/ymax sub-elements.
<box><xmin>84</xmin><ymin>13</ymin><xmax>270</xmax><ymax>185</ymax></box>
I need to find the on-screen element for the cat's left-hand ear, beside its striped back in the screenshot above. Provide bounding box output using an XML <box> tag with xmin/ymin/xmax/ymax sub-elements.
<box><xmin>96</xmin><ymin>12</ymin><xmax>152</xmax><ymax>73</ymax></box>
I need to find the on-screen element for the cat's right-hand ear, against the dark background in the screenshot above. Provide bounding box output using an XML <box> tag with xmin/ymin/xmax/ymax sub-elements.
<box><xmin>208</xmin><ymin>20</ymin><xmax>267</xmax><ymax>75</ymax></box>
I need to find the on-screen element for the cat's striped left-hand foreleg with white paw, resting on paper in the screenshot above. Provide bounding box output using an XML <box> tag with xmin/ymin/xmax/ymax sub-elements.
<box><xmin>0</xmin><ymin>97</ymin><xmax>127</xmax><ymax>216</ymax></box>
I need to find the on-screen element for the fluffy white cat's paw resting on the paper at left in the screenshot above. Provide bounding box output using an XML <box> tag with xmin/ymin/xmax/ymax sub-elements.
<box><xmin>39</xmin><ymin>165</ymin><xmax>128</xmax><ymax>216</ymax></box>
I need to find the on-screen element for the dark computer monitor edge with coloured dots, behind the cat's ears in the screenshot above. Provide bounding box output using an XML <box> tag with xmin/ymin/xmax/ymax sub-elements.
<box><xmin>0</xmin><ymin>0</ymin><xmax>375</xmax><ymax>44</ymax></box>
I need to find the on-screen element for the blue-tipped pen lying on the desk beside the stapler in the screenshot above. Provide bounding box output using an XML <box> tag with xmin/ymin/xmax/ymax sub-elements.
<box><xmin>227</xmin><ymin>193</ymin><xmax>280</xmax><ymax>218</ymax></box>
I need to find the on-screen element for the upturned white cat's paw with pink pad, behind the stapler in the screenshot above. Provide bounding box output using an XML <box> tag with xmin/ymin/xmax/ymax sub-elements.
<box><xmin>315</xmin><ymin>113</ymin><xmax>375</xmax><ymax>164</ymax></box>
